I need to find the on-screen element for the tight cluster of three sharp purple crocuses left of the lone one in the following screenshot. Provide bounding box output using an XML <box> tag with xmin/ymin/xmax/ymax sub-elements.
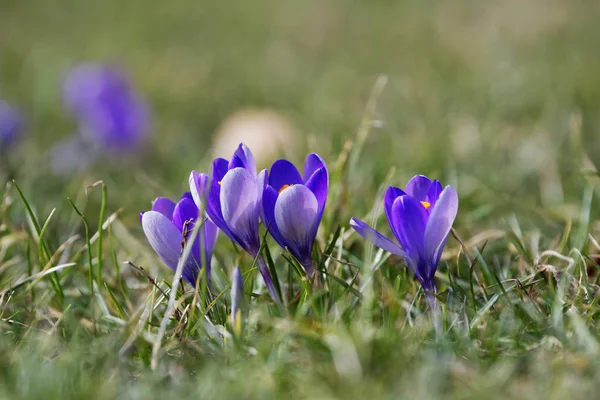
<box><xmin>142</xmin><ymin>143</ymin><xmax>329</xmax><ymax>304</ymax></box>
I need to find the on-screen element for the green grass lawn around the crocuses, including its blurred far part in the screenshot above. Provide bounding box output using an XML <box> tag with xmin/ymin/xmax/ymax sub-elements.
<box><xmin>0</xmin><ymin>0</ymin><xmax>600</xmax><ymax>400</ymax></box>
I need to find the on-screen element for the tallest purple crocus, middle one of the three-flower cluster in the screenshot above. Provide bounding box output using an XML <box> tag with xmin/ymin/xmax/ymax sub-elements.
<box><xmin>190</xmin><ymin>143</ymin><xmax>281</xmax><ymax>305</ymax></box>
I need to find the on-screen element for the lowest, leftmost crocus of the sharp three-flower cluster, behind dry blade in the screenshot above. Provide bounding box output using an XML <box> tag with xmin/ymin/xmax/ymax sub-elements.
<box><xmin>141</xmin><ymin>193</ymin><xmax>219</xmax><ymax>286</ymax></box>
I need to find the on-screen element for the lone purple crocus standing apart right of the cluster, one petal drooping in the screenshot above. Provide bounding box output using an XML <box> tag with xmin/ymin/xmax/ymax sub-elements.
<box><xmin>350</xmin><ymin>175</ymin><xmax>458</xmax><ymax>308</ymax></box>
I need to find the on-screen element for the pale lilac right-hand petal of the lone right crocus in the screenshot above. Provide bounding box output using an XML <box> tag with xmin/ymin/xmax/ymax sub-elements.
<box><xmin>424</xmin><ymin>186</ymin><xmax>458</xmax><ymax>267</ymax></box>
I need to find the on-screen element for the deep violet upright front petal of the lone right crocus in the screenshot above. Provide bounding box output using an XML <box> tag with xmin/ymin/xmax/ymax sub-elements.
<box><xmin>391</xmin><ymin>196</ymin><xmax>427</xmax><ymax>273</ymax></box>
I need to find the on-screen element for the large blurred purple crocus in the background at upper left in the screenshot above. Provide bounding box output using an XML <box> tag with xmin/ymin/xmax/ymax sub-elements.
<box><xmin>63</xmin><ymin>63</ymin><xmax>150</xmax><ymax>152</ymax></box>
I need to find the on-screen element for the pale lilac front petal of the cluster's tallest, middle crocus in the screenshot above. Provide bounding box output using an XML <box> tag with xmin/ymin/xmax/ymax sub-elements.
<box><xmin>215</xmin><ymin>168</ymin><xmax>260</xmax><ymax>254</ymax></box>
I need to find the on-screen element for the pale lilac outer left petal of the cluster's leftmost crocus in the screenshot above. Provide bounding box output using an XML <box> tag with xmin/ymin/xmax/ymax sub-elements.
<box><xmin>142</xmin><ymin>211</ymin><xmax>183</xmax><ymax>270</ymax></box>
